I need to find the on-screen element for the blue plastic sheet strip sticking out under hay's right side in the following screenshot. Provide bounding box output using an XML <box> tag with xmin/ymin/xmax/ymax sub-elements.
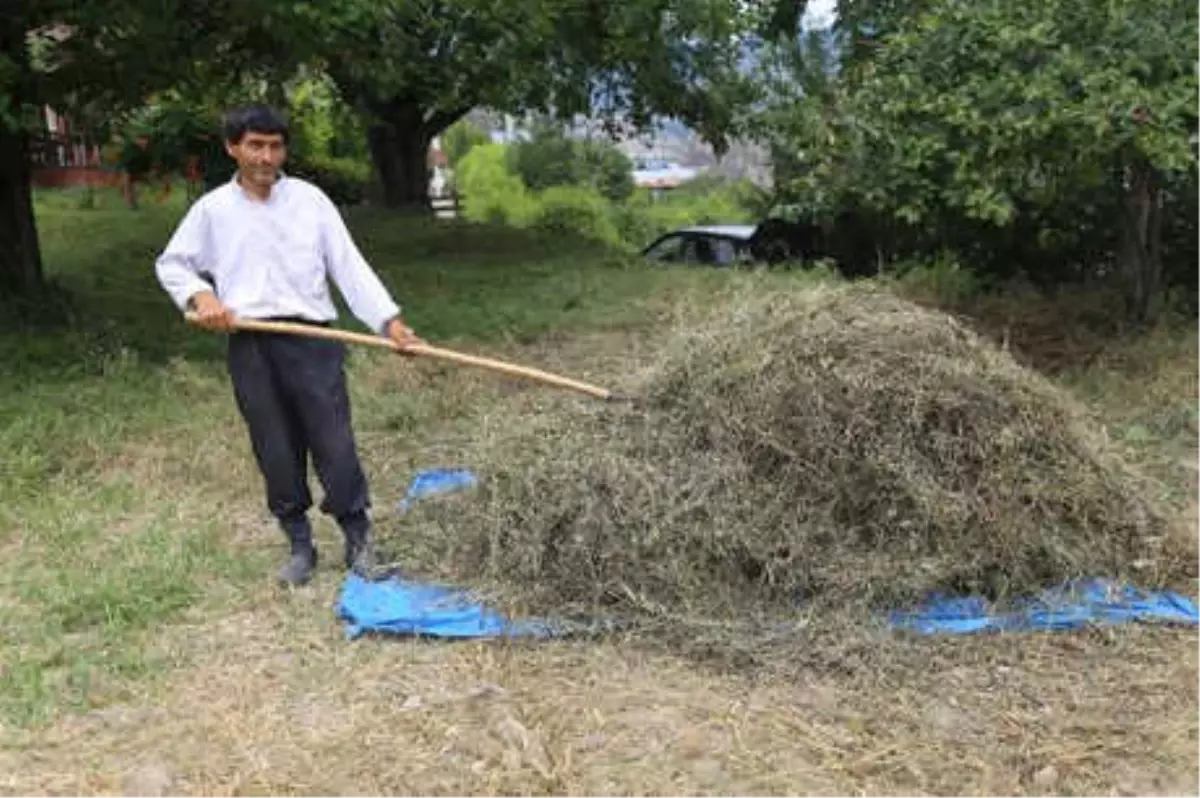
<box><xmin>889</xmin><ymin>580</ymin><xmax>1200</xmax><ymax>635</ymax></box>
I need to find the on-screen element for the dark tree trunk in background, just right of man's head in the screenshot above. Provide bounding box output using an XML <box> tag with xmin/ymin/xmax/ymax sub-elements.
<box><xmin>367</xmin><ymin>103</ymin><xmax>433</xmax><ymax>210</ymax></box>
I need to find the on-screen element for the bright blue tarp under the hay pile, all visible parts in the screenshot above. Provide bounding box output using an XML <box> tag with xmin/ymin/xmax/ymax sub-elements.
<box><xmin>337</xmin><ymin>469</ymin><xmax>1200</xmax><ymax>638</ymax></box>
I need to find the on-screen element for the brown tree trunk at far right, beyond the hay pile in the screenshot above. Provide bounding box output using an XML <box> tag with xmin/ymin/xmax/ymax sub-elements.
<box><xmin>1120</xmin><ymin>160</ymin><xmax>1164</xmax><ymax>324</ymax></box>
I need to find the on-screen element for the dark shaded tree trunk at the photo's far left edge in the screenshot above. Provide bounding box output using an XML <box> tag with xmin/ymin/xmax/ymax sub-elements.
<box><xmin>0</xmin><ymin>122</ymin><xmax>42</xmax><ymax>293</ymax></box>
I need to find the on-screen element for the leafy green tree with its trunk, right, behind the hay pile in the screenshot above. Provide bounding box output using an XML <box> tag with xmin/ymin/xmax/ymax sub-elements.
<box><xmin>768</xmin><ymin>0</ymin><xmax>1200</xmax><ymax>320</ymax></box>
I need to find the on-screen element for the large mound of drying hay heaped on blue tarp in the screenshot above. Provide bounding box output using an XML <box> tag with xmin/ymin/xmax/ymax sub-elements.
<box><xmin>403</xmin><ymin>286</ymin><xmax>1168</xmax><ymax>638</ymax></box>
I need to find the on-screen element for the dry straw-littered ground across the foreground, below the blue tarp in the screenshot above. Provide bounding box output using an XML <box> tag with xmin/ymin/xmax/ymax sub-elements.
<box><xmin>0</xmin><ymin>600</ymin><xmax>1200</xmax><ymax>796</ymax></box>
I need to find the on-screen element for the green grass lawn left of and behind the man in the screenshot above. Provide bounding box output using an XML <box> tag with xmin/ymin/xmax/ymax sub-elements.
<box><xmin>0</xmin><ymin>192</ymin><xmax>744</xmax><ymax>725</ymax></box>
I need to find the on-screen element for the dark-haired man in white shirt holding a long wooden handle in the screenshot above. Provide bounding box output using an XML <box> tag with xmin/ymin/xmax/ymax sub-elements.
<box><xmin>156</xmin><ymin>106</ymin><xmax>421</xmax><ymax>584</ymax></box>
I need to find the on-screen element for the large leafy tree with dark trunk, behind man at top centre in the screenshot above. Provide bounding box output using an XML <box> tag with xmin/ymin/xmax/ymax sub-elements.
<box><xmin>280</xmin><ymin>0</ymin><xmax>757</xmax><ymax>206</ymax></box>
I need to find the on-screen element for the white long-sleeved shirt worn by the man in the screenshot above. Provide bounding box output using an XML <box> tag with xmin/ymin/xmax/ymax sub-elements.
<box><xmin>155</xmin><ymin>175</ymin><xmax>400</xmax><ymax>334</ymax></box>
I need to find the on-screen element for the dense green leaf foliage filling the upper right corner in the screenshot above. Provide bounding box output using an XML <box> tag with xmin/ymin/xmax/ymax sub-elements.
<box><xmin>761</xmin><ymin>0</ymin><xmax>1200</xmax><ymax>317</ymax></box>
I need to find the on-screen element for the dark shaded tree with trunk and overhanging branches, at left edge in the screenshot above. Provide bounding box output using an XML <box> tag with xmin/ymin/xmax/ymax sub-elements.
<box><xmin>0</xmin><ymin>0</ymin><xmax>280</xmax><ymax>292</ymax></box>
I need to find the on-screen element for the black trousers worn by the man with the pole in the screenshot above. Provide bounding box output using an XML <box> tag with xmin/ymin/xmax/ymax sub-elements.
<box><xmin>228</xmin><ymin>332</ymin><xmax>371</xmax><ymax>542</ymax></box>
